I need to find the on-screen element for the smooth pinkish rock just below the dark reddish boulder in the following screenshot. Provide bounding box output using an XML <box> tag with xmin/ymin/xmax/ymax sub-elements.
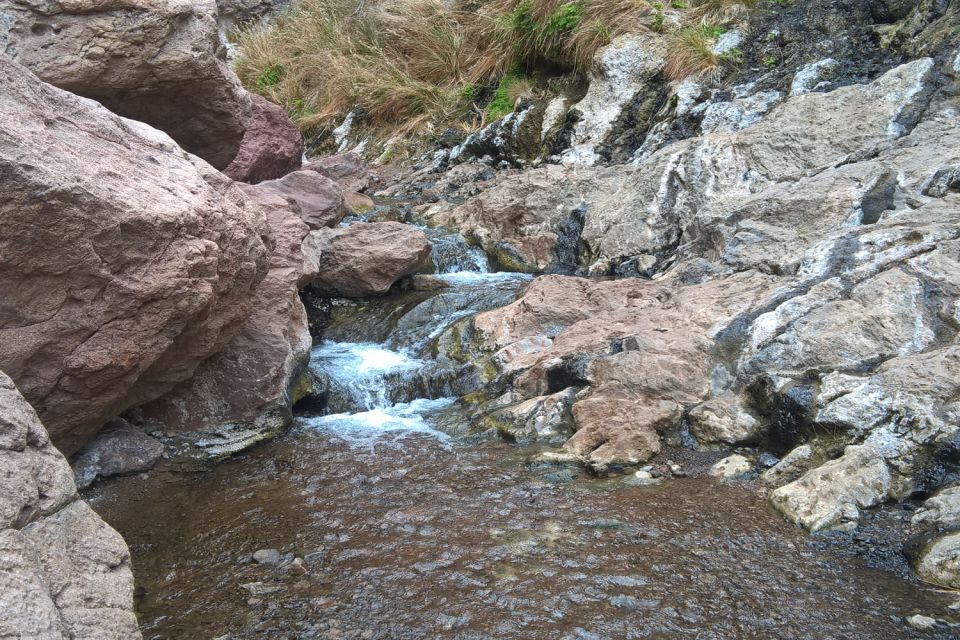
<box><xmin>257</xmin><ymin>169</ymin><xmax>347</xmax><ymax>230</ymax></box>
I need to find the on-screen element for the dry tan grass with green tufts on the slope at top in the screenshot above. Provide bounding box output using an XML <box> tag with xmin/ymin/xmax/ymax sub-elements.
<box><xmin>236</xmin><ymin>0</ymin><xmax>756</xmax><ymax>146</ymax></box>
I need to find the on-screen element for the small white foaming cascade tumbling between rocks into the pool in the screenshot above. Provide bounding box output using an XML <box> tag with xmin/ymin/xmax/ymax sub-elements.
<box><xmin>301</xmin><ymin>222</ymin><xmax>531</xmax><ymax>447</ymax></box>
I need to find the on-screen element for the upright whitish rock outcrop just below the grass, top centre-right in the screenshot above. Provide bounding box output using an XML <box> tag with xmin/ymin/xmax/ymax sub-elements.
<box><xmin>560</xmin><ymin>34</ymin><xmax>666</xmax><ymax>165</ymax></box>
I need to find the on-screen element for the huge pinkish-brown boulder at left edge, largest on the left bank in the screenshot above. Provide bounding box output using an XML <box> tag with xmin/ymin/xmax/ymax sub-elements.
<box><xmin>0</xmin><ymin>56</ymin><xmax>269</xmax><ymax>454</ymax></box>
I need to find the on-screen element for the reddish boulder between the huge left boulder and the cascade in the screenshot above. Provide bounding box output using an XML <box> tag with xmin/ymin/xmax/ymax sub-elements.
<box><xmin>132</xmin><ymin>185</ymin><xmax>317</xmax><ymax>450</ymax></box>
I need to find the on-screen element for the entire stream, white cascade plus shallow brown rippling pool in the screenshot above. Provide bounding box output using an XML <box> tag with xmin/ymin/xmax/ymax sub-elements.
<box><xmin>87</xmin><ymin>219</ymin><xmax>951</xmax><ymax>640</ymax></box>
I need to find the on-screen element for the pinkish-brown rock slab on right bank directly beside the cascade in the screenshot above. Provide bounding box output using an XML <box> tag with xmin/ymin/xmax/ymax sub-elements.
<box><xmin>474</xmin><ymin>273</ymin><xmax>775</xmax><ymax>467</ymax></box>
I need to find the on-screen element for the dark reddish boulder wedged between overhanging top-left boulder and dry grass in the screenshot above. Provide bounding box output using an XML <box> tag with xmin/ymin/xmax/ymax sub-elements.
<box><xmin>223</xmin><ymin>95</ymin><xmax>303</xmax><ymax>183</ymax></box>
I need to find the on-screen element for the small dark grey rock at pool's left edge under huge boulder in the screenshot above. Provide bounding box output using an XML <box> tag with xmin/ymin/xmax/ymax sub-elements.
<box><xmin>72</xmin><ymin>418</ymin><xmax>163</xmax><ymax>489</ymax></box>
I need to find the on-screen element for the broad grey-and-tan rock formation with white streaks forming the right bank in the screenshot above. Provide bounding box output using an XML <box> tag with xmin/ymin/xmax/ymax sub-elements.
<box><xmin>436</xmin><ymin>50</ymin><xmax>960</xmax><ymax>552</ymax></box>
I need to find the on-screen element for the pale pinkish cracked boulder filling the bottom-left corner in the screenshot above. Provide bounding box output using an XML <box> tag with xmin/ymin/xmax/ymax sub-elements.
<box><xmin>0</xmin><ymin>373</ymin><xmax>141</xmax><ymax>640</ymax></box>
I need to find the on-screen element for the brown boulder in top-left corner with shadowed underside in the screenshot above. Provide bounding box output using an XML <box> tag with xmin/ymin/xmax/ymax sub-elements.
<box><xmin>0</xmin><ymin>0</ymin><xmax>250</xmax><ymax>169</ymax></box>
